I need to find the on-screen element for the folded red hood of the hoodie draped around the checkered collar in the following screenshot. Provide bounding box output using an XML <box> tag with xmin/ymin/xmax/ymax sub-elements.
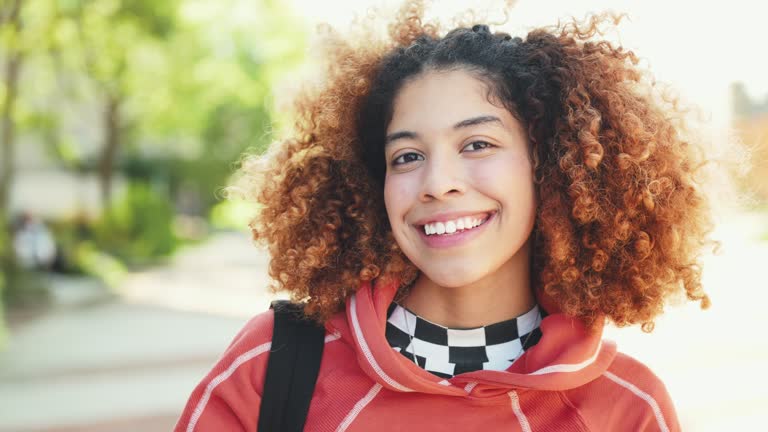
<box><xmin>329</xmin><ymin>281</ymin><xmax>616</xmax><ymax>398</ymax></box>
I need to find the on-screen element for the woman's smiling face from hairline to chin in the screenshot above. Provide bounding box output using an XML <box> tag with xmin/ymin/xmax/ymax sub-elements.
<box><xmin>384</xmin><ymin>70</ymin><xmax>536</xmax><ymax>287</ymax></box>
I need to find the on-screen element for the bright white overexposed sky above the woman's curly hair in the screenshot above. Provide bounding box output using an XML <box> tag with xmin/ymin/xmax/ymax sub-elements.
<box><xmin>291</xmin><ymin>0</ymin><xmax>768</xmax><ymax>131</ymax></box>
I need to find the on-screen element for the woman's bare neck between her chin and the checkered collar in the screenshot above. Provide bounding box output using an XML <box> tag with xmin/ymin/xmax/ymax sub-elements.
<box><xmin>402</xmin><ymin>241</ymin><xmax>535</xmax><ymax>328</ymax></box>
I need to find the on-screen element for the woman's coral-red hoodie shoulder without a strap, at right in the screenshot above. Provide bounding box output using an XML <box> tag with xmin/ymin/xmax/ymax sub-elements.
<box><xmin>566</xmin><ymin>352</ymin><xmax>680</xmax><ymax>432</ymax></box>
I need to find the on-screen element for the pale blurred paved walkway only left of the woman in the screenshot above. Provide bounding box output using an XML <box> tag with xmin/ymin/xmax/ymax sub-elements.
<box><xmin>0</xmin><ymin>233</ymin><xmax>270</xmax><ymax>432</ymax></box>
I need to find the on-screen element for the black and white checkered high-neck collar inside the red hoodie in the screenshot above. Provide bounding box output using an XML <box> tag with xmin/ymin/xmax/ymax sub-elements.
<box><xmin>386</xmin><ymin>303</ymin><xmax>541</xmax><ymax>378</ymax></box>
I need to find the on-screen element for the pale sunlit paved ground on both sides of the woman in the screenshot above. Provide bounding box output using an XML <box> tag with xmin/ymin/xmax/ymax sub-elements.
<box><xmin>0</xmin><ymin>215</ymin><xmax>768</xmax><ymax>432</ymax></box>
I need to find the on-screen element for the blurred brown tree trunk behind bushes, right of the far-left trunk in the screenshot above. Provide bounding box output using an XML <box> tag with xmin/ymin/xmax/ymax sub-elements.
<box><xmin>99</xmin><ymin>92</ymin><xmax>120</xmax><ymax>216</ymax></box>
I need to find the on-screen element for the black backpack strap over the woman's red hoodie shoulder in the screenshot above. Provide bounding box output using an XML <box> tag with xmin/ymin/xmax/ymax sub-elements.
<box><xmin>258</xmin><ymin>300</ymin><xmax>325</xmax><ymax>432</ymax></box>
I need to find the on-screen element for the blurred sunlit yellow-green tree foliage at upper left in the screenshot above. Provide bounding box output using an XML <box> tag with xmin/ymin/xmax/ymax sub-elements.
<box><xmin>0</xmin><ymin>0</ymin><xmax>305</xmax><ymax>330</ymax></box>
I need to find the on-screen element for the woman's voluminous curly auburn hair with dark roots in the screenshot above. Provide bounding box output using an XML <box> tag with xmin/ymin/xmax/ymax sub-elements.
<box><xmin>242</xmin><ymin>1</ymin><xmax>711</xmax><ymax>331</ymax></box>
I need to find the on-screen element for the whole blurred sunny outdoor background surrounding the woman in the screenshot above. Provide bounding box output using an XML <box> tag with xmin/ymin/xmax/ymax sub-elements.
<box><xmin>0</xmin><ymin>0</ymin><xmax>768</xmax><ymax>431</ymax></box>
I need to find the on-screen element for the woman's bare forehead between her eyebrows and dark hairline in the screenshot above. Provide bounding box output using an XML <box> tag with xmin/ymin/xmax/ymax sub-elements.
<box><xmin>387</xmin><ymin>70</ymin><xmax>514</xmax><ymax>133</ymax></box>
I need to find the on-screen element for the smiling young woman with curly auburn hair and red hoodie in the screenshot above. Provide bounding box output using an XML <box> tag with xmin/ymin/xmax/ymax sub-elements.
<box><xmin>177</xmin><ymin>2</ymin><xmax>709</xmax><ymax>431</ymax></box>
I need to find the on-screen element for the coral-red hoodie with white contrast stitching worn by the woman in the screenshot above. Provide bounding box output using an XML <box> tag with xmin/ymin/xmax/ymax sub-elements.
<box><xmin>175</xmin><ymin>278</ymin><xmax>680</xmax><ymax>432</ymax></box>
